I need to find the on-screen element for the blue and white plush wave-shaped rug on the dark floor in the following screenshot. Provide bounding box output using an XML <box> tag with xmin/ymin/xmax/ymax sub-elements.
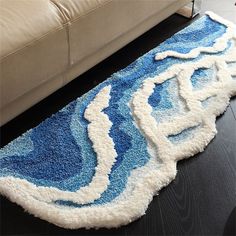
<box><xmin>0</xmin><ymin>12</ymin><xmax>236</xmax><ymax>228</ymax></box>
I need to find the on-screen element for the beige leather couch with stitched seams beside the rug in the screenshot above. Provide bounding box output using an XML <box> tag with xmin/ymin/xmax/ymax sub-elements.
<box><xmin>0</xmin><ymin>0</ymin><xmax>190</xmax><ymax>125</ymax></box>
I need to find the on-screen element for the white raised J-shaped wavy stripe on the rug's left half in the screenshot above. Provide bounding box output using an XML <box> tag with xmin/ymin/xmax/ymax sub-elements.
<box><xmin>0</xmin><ymin>86</ymin><xmax>117</xmax><ymax>204</ymax></box>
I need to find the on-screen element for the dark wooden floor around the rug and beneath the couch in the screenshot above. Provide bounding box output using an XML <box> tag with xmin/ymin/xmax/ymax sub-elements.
<box><xmin>0</xmin><ymin>0</ymin><xmax>236</xmax><ymax>235</ymax></box>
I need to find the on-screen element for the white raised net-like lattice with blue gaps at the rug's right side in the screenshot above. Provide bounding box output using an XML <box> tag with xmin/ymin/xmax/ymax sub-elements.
<box><xmin>132</xmin><ymin>49</ymin><xmax>236</xmax><ymax>161</ymax></box>
